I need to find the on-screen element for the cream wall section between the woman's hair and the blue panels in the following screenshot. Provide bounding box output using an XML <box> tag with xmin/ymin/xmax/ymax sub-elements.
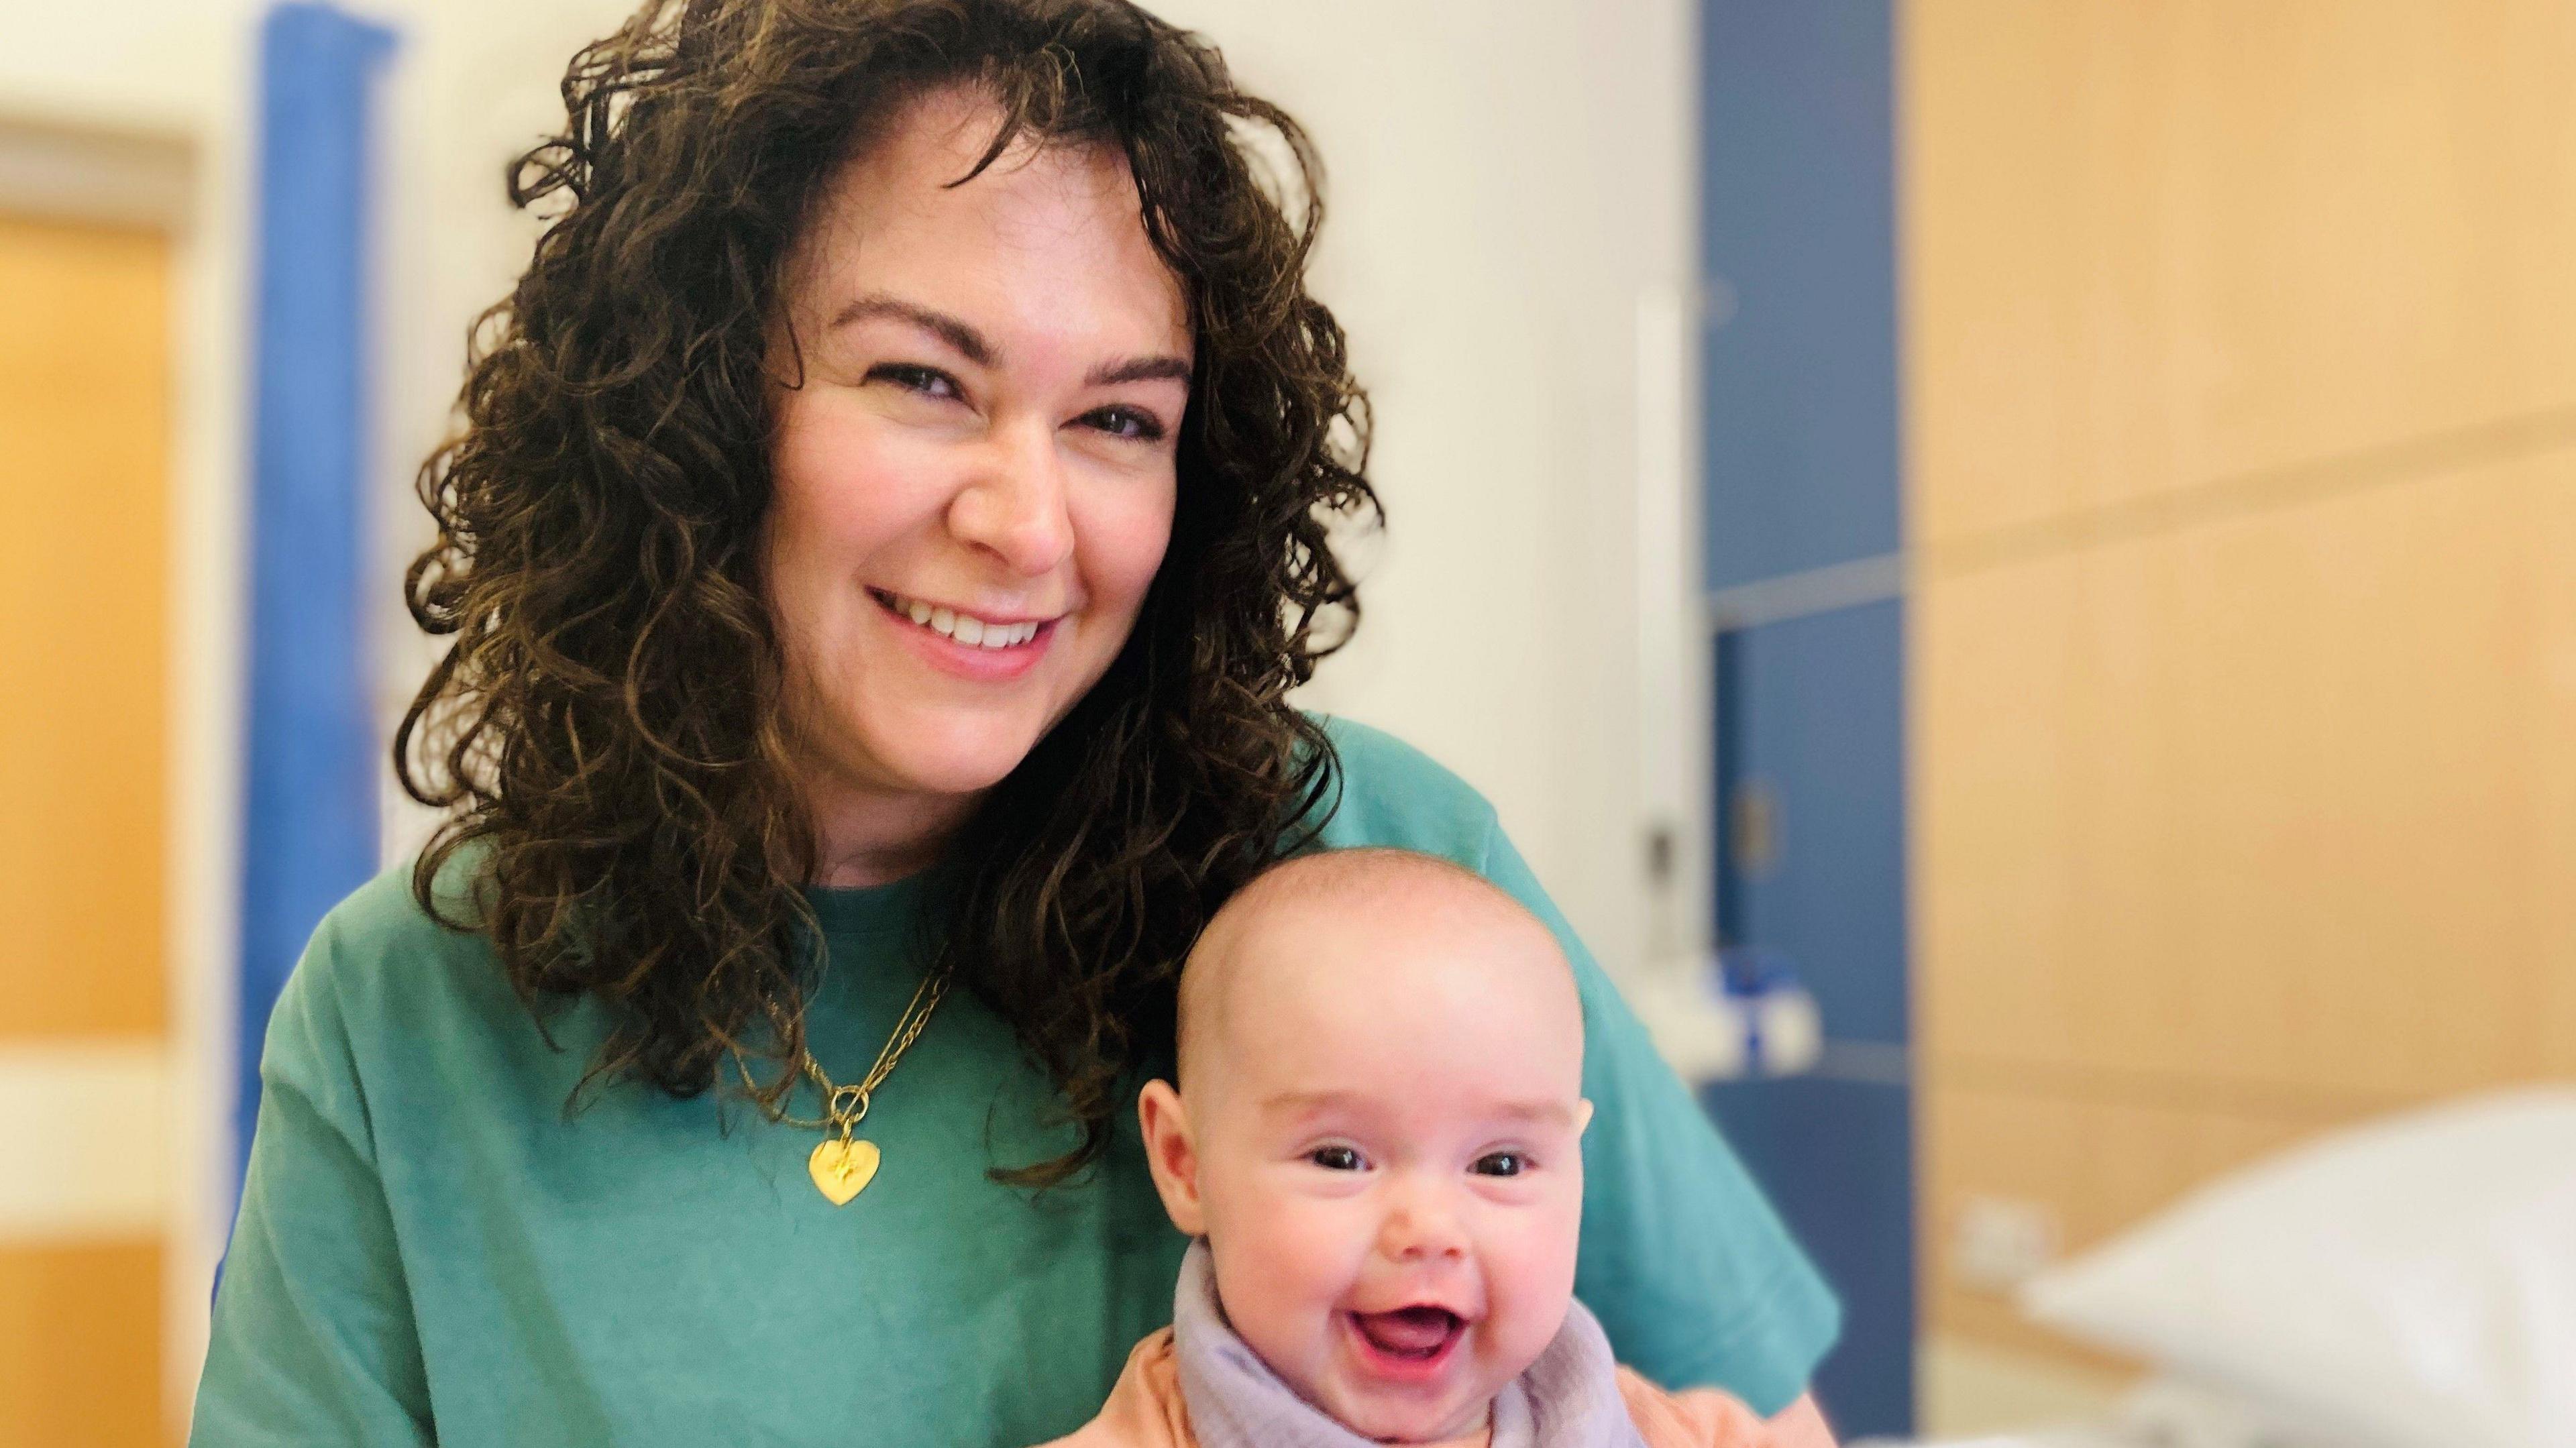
<box><xmin>1159</xmin><ymin>0</ymin><xmax>1695</xmax><ymax>968</ymax></box>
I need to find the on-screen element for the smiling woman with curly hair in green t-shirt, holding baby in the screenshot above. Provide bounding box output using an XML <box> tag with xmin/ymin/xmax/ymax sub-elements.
<box><xmin>196</xmin><ymin>0</ymin><xmax>1834</xmax><ymax>1445</ymax></box>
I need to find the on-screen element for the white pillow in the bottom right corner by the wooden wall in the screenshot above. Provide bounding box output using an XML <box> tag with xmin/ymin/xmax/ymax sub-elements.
<box><xmin>2022</xmin><ymin>1084</ymin><xmax>2576</xmax><ymax>1448</ymax></box>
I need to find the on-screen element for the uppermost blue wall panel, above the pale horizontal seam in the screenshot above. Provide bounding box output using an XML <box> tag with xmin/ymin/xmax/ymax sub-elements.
<box><xmin>1700</xmin><ymin>0</ymin><xmax>1898</xmax><ymax>588</ymax></box>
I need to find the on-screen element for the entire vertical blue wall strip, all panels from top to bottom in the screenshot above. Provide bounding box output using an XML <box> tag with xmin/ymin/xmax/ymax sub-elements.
<box><xmin>1700</xmin><ymin>0</ymin><xmax>1914</xmax><ymax>1435</ymax></box>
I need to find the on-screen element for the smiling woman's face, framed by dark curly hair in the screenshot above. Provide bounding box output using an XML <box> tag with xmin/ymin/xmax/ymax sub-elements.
<box><xmin>765</xmin><ymin>90</ymin><xmax>1190</xmax><ymax>834</ymax></box>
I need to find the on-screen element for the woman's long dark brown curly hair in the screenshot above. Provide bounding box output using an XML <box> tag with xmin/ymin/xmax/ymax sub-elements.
<box><xmin>394</xmin><ymin>0</ymin><xmax>1378</xmax><ymax>1185</ymax></box>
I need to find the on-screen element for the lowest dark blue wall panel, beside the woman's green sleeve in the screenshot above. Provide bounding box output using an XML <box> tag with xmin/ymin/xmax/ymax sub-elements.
<box><xmin>1700</xmin><ymin>1077</ymin><xmax>1914</xmax><ymax>1440</ymax></box>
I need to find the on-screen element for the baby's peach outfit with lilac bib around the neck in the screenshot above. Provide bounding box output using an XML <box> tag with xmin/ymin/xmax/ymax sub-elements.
<box><xmin>1049</xmin><ymin>1242</ymin><xmax>1770</xmax><ymax>1448</ymax></box>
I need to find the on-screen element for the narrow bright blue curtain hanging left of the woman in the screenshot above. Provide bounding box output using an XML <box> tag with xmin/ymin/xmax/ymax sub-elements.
<box><xmin>234</xmin><ymin>3</ymin><xmax>394</xmax><ymax>1182</ymax></box>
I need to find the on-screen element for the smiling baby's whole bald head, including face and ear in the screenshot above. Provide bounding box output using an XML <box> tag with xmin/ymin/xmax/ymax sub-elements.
<box><xmin>1138</xmin><ymin>850</ymin><xmax>1592</xmax><ymax>1443</ymax></box>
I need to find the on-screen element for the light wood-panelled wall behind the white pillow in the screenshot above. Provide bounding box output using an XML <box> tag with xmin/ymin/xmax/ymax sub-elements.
<box><xmin>1898</xmin><ymin>0</ymin><xmax>2576</xmax><ymax>1360</ymax></box>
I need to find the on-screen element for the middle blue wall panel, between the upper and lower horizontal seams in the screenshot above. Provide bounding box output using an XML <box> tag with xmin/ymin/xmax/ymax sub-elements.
<box><xmin>1715</xmin><ymin>600</ymin><xmax>1909</xmax><ymax>1046</ymax></box>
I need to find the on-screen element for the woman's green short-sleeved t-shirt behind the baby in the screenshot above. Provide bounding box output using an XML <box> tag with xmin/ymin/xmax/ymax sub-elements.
<box><xmin>193</xmin><ymin>722</ymin><xmax>1839</xmax><ymax>1448</ymax></box>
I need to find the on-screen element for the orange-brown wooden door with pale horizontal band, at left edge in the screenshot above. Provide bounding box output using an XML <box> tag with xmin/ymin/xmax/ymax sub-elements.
<box><xmin>0</xmin><ymin>214</ymin><xmax>172</xmax><ymax>1448</ymax></box>
